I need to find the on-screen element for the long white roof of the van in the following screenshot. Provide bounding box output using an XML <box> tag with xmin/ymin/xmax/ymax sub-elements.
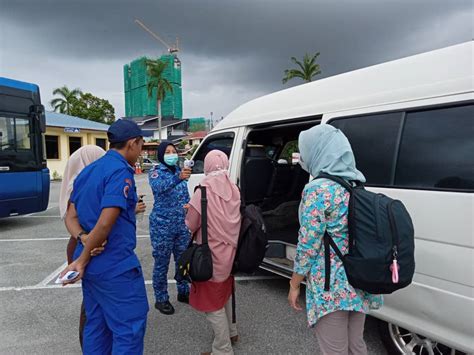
<box><xmin>215</xmin><ymin>41</ymin><xmax>474</xmax><ymax>130</ymax></box>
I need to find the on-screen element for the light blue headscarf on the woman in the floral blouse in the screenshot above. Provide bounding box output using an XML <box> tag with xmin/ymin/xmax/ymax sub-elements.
<box><xmin>298</xmin><ymin>124</ymin><xmax>365</xmax><ymax>182</ymax></box>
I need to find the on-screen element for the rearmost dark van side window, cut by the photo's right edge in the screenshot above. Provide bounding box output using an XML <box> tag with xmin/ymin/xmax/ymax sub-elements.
<box><xmin>395</xmin><ymin>105</ymin><xmax>474</xmax><ymax>190</ymax></box>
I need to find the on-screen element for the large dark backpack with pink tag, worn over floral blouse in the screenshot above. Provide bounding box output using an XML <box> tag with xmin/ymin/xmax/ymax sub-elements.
<box><xmin>317</xmin><ymin>174</ymin><xmax>415</xmax><ymax>294</ymax></box>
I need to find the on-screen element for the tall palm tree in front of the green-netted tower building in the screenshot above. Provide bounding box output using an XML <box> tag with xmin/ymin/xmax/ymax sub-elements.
<box><xmin>147</xmin><ymin>59</ymin><xmax>173</xmax><ymax>142</ymax></box>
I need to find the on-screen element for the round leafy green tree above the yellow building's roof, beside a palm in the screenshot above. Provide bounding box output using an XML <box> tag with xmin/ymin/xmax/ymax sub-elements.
<box><xmin>70</xmin><ymin>92</ymin><xmax>115</xmax><ymax>124</ymax></box>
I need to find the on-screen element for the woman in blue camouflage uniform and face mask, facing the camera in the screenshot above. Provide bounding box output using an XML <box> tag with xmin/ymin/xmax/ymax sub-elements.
<box><xmin>148</xmin><ymin>141</ymin><xmax>191</xmax><ymax>314</ymax></box>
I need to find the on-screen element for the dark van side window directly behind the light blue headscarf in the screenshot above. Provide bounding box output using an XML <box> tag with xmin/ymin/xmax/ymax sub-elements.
<box><xmin>330</xmin><ymin>112</ymin><xmax>402</xmax><ymax>185</ymax></box>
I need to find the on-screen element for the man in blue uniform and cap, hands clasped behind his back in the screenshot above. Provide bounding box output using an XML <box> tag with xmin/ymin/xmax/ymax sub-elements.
<box><xmin>62</xmin><ymin>120</ymin><xmax>149</xmax><ymax>354</ymax></box>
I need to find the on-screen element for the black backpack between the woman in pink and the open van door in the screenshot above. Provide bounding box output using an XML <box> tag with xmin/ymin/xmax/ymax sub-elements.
<box><xmin>232</xmin><ymin>205</ymin><xmax>268</xmax><ymax>274</ymax></box>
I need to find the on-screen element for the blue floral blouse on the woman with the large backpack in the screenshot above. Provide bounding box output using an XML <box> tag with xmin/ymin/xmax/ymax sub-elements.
<box><xmin>294</xmin><ymin>179</ymin><xmax>383</xmax><ymax>326</ymax></box>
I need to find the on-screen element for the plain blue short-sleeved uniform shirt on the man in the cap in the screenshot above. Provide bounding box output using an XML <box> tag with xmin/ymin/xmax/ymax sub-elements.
<box><xmin>71</xmin><ymin>150</ymin><xmax>140</xmax><ymax>279</ymax></box>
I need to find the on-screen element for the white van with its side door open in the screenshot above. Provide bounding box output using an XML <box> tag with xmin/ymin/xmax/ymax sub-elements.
<box><xmin>189</xmin><ymin>42</ymin><xmax>474</xmax><ymax>354</ymax></box>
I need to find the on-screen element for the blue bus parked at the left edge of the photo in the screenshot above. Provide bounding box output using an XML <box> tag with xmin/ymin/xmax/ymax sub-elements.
<box><xmin>0</xmin><ymin>77</ymin><xmax>49</xmax><ymax>218</ymax></box>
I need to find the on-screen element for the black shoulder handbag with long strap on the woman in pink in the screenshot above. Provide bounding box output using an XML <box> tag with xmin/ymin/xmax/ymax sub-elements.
<box><xmin>176</xmin><ymin>186</ymin><xmax>213</xmax><ymax>282</ymax></box>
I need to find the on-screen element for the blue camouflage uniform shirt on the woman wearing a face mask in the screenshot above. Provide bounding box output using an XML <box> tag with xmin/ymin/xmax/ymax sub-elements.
<box><xmin>148</xmin><ymin>164</ymin><xmax>189</xmax><ymax>223</ymax></box>
